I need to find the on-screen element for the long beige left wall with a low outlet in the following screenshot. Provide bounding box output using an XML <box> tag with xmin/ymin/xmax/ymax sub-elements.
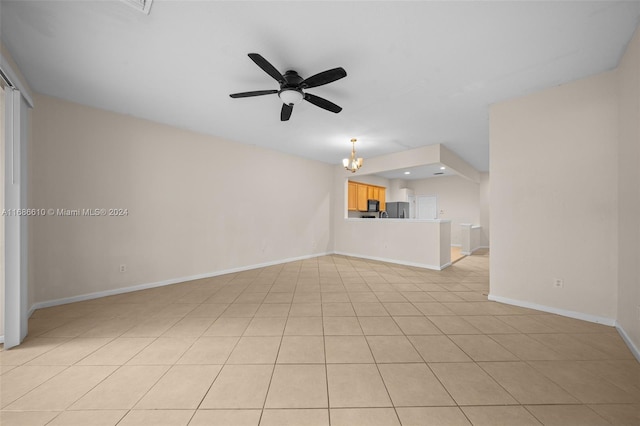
<box><xmin>30</xmin><ymin>96</ymin><xmax>333</xmax><ymax>302</ymax></box>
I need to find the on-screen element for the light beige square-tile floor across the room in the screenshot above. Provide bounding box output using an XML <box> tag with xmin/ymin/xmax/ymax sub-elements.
<box><xmin>0</xmin><ymin>254</ymin><xmax>640</xmax><ymax>426</ymax></box>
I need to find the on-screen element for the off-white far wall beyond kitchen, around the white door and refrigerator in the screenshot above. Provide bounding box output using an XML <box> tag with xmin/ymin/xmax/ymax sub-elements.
<box><xmin>407</xmin><ymin>176</ymin><xmax>480</xmax><ymax>245</ymax></box>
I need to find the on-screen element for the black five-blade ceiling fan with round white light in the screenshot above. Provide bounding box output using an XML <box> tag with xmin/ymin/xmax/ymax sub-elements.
<box><xmin>229</xmin><ymin>53</ymin><xmax>347</xmax><ymax>121</ymax></box>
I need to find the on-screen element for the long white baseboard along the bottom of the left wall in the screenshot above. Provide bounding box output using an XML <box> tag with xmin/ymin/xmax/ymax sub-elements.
<box><xmin>28</xmin><ymin>252</ymin><xmax>332</xmax><ymax>317</ymax></box>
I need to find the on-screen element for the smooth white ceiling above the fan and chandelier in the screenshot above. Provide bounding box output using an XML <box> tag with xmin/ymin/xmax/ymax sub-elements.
<box><xmin>0</xmin><ymin>0</ymin><xmax>640</xmax><ymax>171</ymax></box>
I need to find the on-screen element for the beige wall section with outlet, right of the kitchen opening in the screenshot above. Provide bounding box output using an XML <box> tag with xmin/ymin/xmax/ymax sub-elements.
<box><xmin>490</xmin><ymin>72</ymin><xmax>618</xmax><ymax>323</ymax></box>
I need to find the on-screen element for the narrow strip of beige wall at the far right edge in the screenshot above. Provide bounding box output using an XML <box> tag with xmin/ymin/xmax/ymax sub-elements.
<box><xmin>617</xmin><ymin>25</ymin><xmax>640</xmax><ymax>348</ymax></box>
